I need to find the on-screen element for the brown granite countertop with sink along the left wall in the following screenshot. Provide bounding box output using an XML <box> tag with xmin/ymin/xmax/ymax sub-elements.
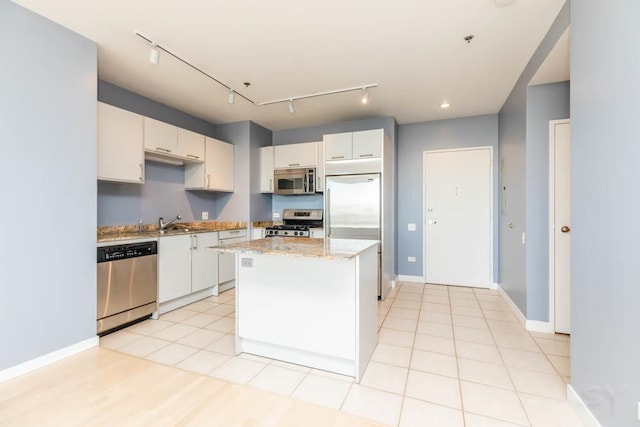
<box><xmin>97</xmin><ymin>221</ymin><xmax>247</xmax><ymax>243</ymax></box>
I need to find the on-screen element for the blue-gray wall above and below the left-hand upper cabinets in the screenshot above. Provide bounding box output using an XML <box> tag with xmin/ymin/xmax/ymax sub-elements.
<box><xmin>98</xmin><ymin>81</ymin><xmax>219</xmax><ymax>226</ymax></box>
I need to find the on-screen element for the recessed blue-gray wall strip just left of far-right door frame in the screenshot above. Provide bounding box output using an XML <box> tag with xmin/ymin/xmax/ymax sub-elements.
<box><xmin>526</xmin><ymin>82</ymin><xmax>569</xmax><ymax>321</ymax></box>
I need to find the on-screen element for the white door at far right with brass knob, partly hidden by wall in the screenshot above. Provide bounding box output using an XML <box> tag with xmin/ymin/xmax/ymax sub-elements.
<box><xmin>550</xmin><ymin>120</ymin><xmax>571</xmax><ymax>334</ymax></box>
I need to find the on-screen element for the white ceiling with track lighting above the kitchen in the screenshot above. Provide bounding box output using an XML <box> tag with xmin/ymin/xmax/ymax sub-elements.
<box><xmin>15</xmin><ymin>0</ymin><xmax>565</xmax><ymax>130</ymax></box>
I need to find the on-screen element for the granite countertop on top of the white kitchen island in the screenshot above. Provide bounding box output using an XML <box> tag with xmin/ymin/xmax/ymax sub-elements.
<box><xmin>211</xmin><ymin>237</ymin><xmax>379</xmax><ymax>259</ymax></box>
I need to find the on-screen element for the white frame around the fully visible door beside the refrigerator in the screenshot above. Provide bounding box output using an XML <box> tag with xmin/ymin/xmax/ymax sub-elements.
<box><xmin>422</xmin><ymin>145</ymin><xmax>495</xmax><ymax>289</ymax></box>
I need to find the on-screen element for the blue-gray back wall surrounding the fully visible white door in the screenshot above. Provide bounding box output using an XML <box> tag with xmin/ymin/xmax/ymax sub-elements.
<box><xmin>397</xmin><ymin>115</ymin><xmax>498</xmax><ymax>280</ymax></box>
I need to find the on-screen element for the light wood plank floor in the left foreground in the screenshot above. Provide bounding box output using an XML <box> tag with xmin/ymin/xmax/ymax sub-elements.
<box><xmin>0</xmin><ymin>348</ymin><xmax>378</xmax><ymax>427</ymax></box>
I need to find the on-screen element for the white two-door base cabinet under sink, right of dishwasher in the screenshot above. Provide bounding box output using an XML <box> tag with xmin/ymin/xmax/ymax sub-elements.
<box><xmin>158</xmin><ymin>232</ymin><xmax>218</xmax><ymax>308</ymax></box>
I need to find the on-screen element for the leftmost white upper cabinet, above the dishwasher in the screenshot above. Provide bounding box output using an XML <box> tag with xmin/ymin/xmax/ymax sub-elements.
<box><xmin>98</xmin><ymin>102</ymin><xmax>144</xmax><ymax>184</ymax></box>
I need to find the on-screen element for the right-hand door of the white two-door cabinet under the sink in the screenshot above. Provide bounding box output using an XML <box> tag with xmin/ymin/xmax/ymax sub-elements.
<box><xmin>191</xmin><ymin>232</ymin><xmax>218</xmax><ymax>294</ymax></box>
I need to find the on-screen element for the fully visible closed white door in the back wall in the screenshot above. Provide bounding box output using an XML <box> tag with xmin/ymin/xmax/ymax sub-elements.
<box><xmin>424</xmin><ymin>147</ymin><xmax>493</xmax><ymax>287</ymax></box>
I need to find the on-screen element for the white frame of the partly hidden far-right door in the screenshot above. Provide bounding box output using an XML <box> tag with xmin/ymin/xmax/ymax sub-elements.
<box><xmin>549</xmin><ymin>118</ymin><xmax>571</xmax><ymax>333</ymax></box>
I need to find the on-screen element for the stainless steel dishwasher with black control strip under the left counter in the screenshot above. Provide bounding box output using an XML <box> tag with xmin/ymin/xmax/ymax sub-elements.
<box><xmin>97</xmin><ymin>241</ymin><xmax>158</xmax><ymax>335</ymax></box>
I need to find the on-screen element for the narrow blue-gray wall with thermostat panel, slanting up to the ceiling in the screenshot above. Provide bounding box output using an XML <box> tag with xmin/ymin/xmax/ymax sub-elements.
<box><xmin>498</xmin><ymin>2</ymin><xmax>569</xmax><ymax>316</ymax></box>
